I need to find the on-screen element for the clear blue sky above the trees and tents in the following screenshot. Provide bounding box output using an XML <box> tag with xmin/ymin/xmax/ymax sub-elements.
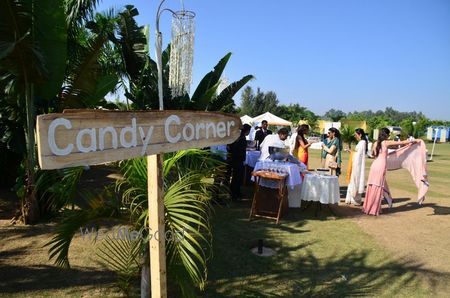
<box><xmin>99</xmin><ymin>0</ymin><xmax>450</xmax><ymax>120</ymax></box>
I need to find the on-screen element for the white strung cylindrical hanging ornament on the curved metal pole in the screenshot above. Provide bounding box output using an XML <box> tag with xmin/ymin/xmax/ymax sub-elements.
<box><xmin>169</xmin><ymin>9</ymin><xmax>195</xmax><ymax>97</ymax></box>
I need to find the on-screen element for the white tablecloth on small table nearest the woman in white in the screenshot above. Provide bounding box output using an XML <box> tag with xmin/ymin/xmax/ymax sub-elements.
<box><xmin>300</xmin><ymin>174</ymin><xmax>340</xmax><ymax>204</ymax></box>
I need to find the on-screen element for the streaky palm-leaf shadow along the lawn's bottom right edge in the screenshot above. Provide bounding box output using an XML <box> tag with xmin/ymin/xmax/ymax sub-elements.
<box><xmin>205</xmin><ymin>251</ymin><xmax>449</xmax><ymax>297</ymax></box>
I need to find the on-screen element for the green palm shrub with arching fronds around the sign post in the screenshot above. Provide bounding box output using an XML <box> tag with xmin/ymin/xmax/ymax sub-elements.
<box><xmin>47</xmin><ymin>149</ymin><xmax>223</xmax><ymax>296</ymax></box>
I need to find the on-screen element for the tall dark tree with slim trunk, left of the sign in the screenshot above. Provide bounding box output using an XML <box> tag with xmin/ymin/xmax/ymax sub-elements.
<box><xmin>0</xmin><ymin>0</ymin><xmax>117</xmax><ymax>223</ymax></box>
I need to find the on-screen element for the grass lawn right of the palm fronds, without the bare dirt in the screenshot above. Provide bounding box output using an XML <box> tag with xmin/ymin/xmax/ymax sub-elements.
<box><xmin>205</xmin><ymin>144</ymin><xmax>450</xmax><ymax>297</ymax></box>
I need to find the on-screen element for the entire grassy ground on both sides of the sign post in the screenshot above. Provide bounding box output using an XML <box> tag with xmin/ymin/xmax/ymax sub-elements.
<box><xmin>0</xmin><ymin>144</ymin><xmax>450</xmax><ymax>297</ymax></box>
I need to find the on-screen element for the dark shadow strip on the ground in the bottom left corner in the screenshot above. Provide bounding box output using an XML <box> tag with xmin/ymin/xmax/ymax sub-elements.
<box><xmin>0</xmin><ymin>264</ymin><xmax>114</xmax><ymax>294</ymax></box>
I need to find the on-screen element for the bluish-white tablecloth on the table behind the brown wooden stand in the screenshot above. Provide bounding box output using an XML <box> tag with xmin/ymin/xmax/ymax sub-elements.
<box><xmin>252</xmin><ymin>160</ymin><xmax>306</xmax><ymax>208</ymax></box>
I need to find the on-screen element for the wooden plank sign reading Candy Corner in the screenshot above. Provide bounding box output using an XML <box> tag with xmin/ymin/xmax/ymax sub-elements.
<box><xmin>37</xmin><ymin>110</ymin><xmax>241</xmax><ymax>169</ymax></box>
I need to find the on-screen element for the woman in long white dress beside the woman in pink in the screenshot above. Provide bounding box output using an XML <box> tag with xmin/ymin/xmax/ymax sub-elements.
<box><xmin>345</xmin><ymin>128</ymin><xmax>368</xmax><ymax>205</ymax></box>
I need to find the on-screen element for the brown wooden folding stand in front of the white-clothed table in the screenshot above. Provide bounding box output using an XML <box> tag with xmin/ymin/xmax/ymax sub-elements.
<box><xmin>249</xmin><ymin>171</ymin><xmax>288</xmax><ymax>224</ymax></box>
